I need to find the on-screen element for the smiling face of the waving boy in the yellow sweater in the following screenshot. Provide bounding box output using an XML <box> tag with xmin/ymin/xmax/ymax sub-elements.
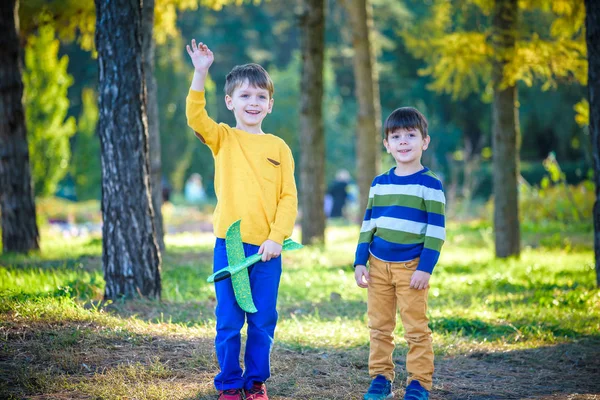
<box><xmin>225</xmin><ymin>80</ymin><xmax>273</xmax><ymax>133</ymax></box>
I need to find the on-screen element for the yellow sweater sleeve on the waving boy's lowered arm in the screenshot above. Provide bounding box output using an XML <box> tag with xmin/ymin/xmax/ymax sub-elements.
<box><xmin>269</xmin><ymin>145</ymin><xmax>298</xmax><ymax>244</ymax></box>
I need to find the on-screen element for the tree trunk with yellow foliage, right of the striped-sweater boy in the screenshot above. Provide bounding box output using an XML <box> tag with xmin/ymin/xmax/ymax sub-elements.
<box><xmin>492</xmin><ymin>0</ymin><xmax>521</xmax><ymax>258</ymax></box>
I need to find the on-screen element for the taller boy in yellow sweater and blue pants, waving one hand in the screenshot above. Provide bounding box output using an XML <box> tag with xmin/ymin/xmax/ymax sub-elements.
<box><xmin>186</xmin><ymin>40</ymin><xmax>298</xmax><ymax>400</ymax></box>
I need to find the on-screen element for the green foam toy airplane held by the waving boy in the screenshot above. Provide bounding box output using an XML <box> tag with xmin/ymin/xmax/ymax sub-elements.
<box><xmin>207</xmin><ymin>220</ymin><xmax>303</xmax><ymax>313</ymax></box>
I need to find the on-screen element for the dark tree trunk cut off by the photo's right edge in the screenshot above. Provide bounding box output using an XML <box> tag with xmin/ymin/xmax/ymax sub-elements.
<box><xmin>585</xmin><ymin>0</ymin><xmax>600</xmax><ymax>287</ymax></box>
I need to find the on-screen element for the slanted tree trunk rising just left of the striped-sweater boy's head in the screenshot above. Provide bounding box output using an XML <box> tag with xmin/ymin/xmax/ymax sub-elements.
<box><xmin>343</xmin><ymin>0</ymin><xmax>383</xmax><ymax>218</ymax></box>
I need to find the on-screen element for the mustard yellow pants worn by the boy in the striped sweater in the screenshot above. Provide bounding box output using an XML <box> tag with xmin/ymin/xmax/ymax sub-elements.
<box><xmin>367</xmin><ymin>256</ymin><xmax>433</xmax><ymax>390</ymax></box>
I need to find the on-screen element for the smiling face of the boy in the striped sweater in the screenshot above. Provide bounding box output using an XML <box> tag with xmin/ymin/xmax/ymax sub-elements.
<box><xmin>383</xmin><ymin>128</ymin><xmax>429</xmax><ymax>167</ymax></box>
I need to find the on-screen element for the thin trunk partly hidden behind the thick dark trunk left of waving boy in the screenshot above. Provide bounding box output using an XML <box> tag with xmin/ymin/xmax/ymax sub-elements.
<box><xmin>142</xmin><ymin>0</ymin><xmax>165</xmax><ymax>252</ymax></box>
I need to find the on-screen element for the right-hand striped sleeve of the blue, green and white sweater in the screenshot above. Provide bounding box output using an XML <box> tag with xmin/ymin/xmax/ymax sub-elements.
<box><xmin>417</xmin><ymin>181</ymin><xmax>446</xmax><ymax>274</ymax></box>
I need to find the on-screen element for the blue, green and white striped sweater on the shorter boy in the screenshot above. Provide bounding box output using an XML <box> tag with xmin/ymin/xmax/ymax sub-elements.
<box><xmin>354</xmin><ymin>167</ymin><xmax>446</xmax><ymax>273</ymax></box>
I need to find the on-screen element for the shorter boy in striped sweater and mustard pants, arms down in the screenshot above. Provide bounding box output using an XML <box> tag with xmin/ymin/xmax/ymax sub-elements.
<box><xmin>354</xmin><ymin>107</ymin><xmax>445</xmax><ymax>400</ymax></box>
